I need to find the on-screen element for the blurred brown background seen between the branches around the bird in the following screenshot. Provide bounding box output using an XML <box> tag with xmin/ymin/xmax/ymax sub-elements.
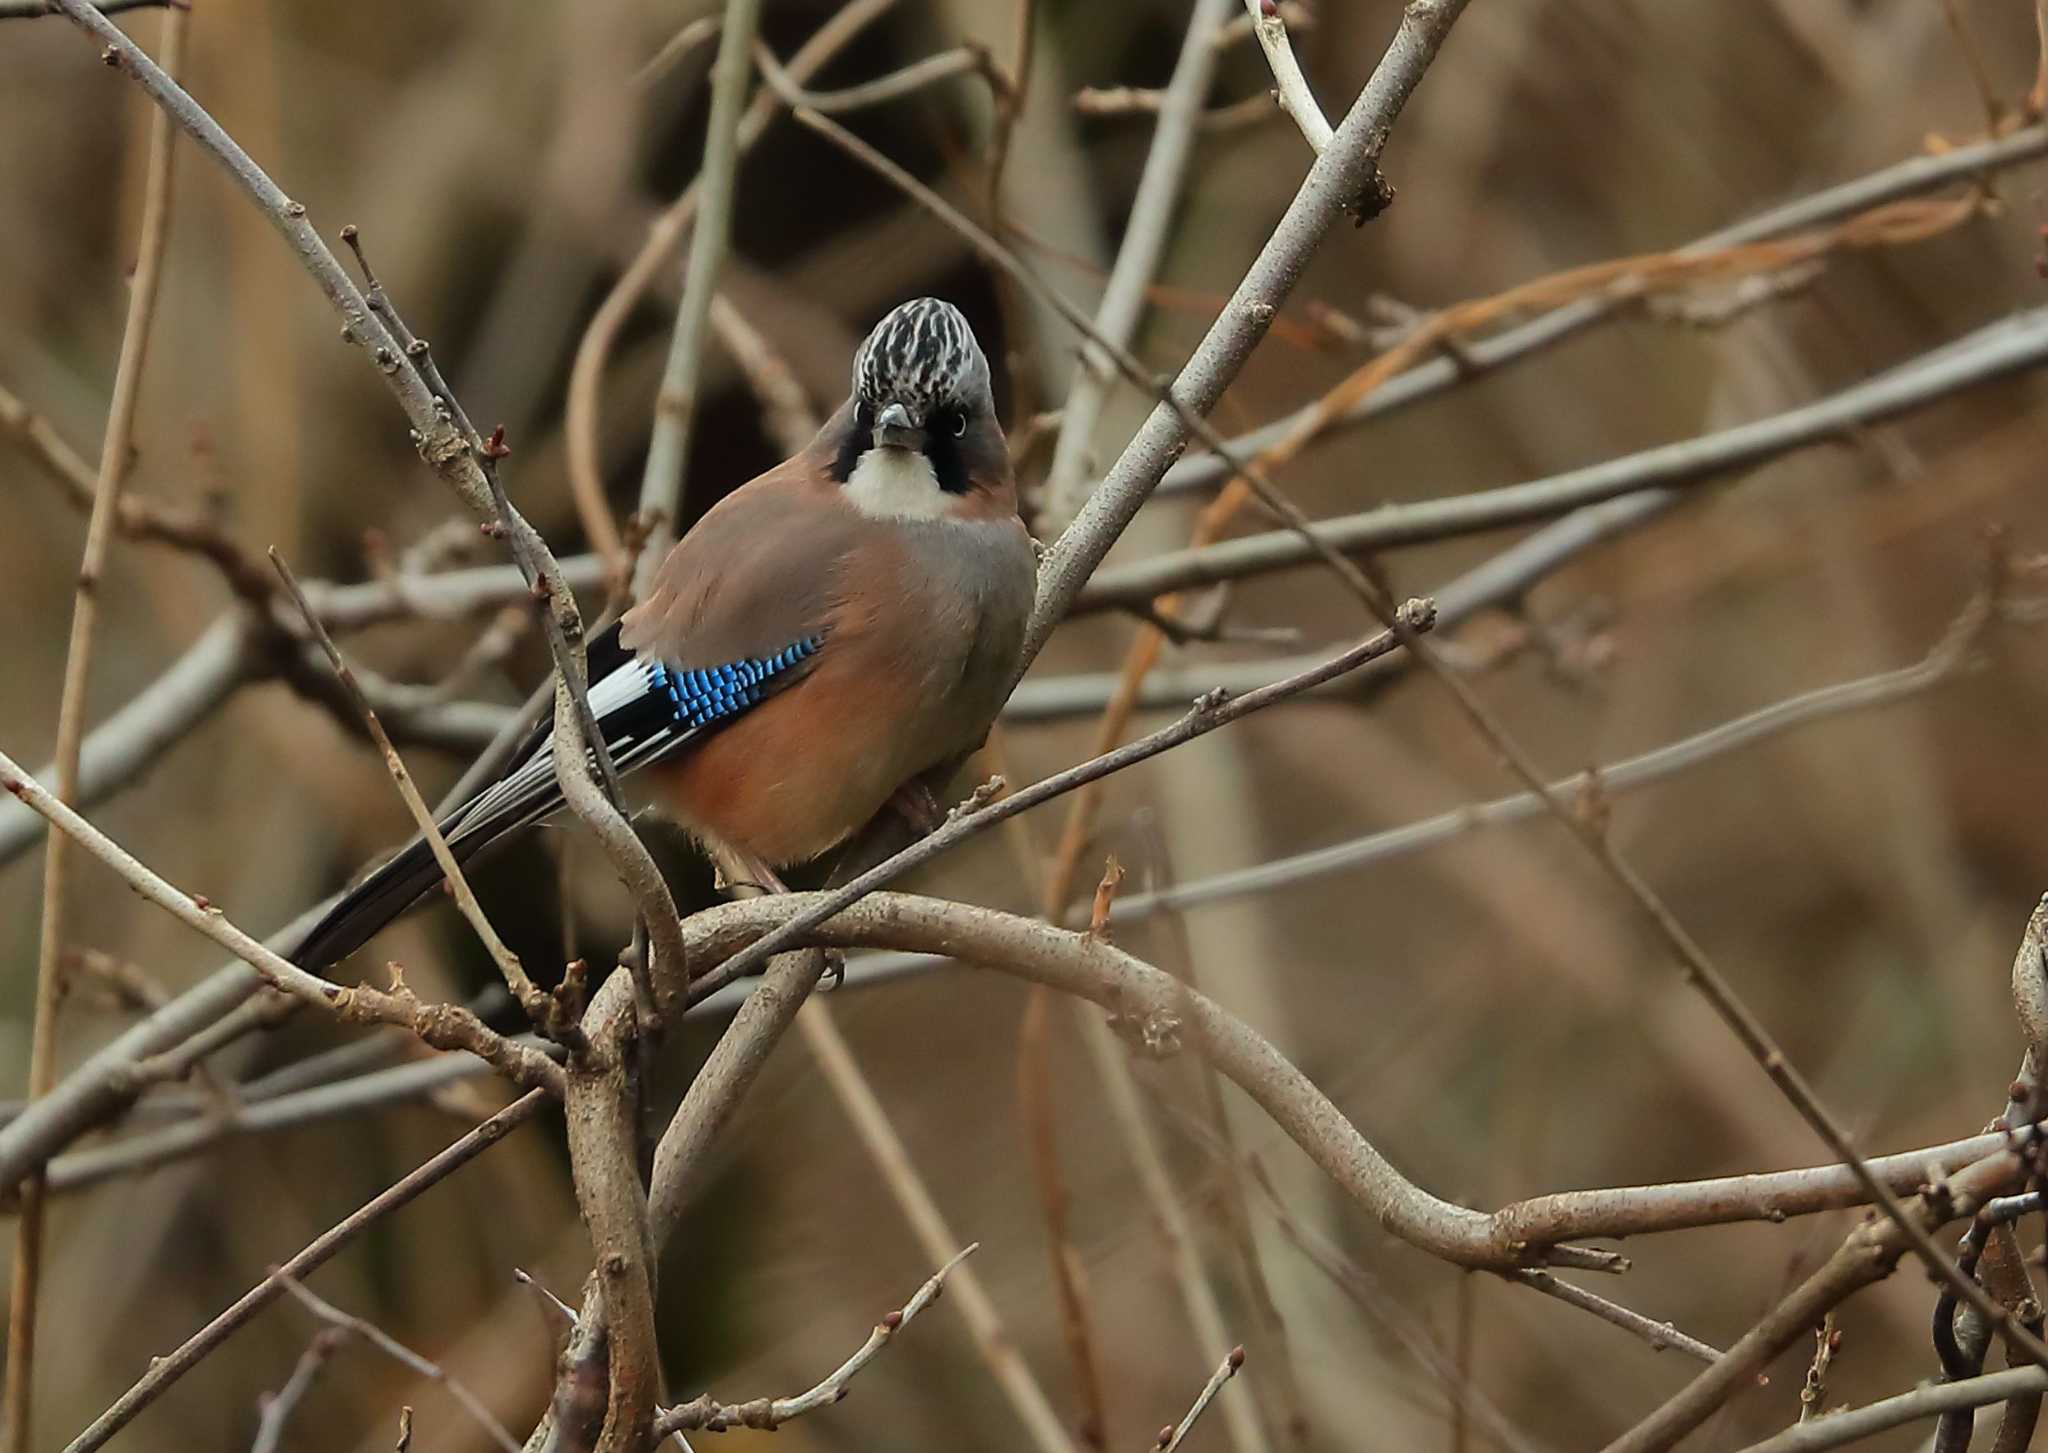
<box><xmin>0</xmin><ymin>0</ymin><xmax>2048</xmax><ymax>1453</ymax></box>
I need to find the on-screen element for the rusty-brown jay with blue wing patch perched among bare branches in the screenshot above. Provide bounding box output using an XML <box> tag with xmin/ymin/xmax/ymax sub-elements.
<box><xmin>293</xmin><ymin>297</ymin><xmax>1036</xmax><ymax>969</ymax></box>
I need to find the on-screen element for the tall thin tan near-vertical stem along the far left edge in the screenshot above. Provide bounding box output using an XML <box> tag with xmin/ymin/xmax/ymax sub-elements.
<box><xmin>0</xmin><ymin>10</ymin><xmax>186</xmax><ymax>1453</ymax></box>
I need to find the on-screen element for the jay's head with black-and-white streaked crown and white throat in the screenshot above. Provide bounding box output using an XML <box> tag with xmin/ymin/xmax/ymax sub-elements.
<box><xmin>825</xmin><ymin>297</ymin><xmax>1014</xmax><ymax>516</ymax></box>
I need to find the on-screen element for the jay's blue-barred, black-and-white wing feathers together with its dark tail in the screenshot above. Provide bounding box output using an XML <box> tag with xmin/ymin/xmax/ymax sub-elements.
<box><xmin>293</xmin><ymin>627</ymin><xmax>821</xmax><ymax>969</ymax></box>
